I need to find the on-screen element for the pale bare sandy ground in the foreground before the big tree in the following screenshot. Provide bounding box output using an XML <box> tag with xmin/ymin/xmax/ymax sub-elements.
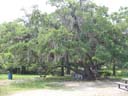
<box><xmin>10</xmin><ymin>81</ymin><xmax>128</xmax><ymax>96</ymax></box>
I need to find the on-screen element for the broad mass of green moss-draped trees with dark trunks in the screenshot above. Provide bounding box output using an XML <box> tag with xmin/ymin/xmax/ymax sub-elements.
<box><xmin>0</xmin><ymin>0</ymin><xmax>128</xmax><ymax>80</ymax></box>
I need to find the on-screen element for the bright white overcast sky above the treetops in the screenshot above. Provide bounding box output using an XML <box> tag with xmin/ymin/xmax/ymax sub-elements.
<box><xmin>0</xmin><ymin>0</ymin><xmax>128</xmax><ymax>23</ymax></box>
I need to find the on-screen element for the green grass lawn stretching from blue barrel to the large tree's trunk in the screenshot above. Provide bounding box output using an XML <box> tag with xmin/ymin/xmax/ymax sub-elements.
<box><xmin>0</xmin><ymin>74</ymin><xmax>72</xmax><ymax>96</ymax></box>
